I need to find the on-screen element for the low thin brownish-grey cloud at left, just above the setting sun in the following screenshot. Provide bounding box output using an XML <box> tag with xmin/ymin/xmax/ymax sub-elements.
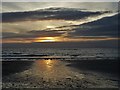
<box><xmin>2</xmin><ymin>30</ymin><xmax>64</xmax><ymax>39</ymax></box>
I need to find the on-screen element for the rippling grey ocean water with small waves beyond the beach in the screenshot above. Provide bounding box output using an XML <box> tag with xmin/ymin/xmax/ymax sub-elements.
<box><xmin>2</xmin><ymin>48</ymin><xmax>118</xmax><ymax>61</ymax></box>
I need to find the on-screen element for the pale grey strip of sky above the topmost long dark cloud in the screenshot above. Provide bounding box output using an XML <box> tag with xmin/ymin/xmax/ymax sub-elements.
<box><xmin>2</xmin><ymin>2</ymin><xmax>118</xmax><ymax>12</ymax></box>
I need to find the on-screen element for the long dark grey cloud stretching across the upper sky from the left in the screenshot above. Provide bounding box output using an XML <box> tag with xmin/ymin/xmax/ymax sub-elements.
<box><xmin>2</xmin><ymin>8</ymin><xmax>109</xmax><ymax>22</ymax></box>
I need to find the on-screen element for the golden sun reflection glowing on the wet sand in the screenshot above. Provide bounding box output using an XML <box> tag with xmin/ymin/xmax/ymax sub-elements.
<box><xmin>26</xmin><ymin>59</ymin><xmax>83</xmax><ymax>80</ymax></box>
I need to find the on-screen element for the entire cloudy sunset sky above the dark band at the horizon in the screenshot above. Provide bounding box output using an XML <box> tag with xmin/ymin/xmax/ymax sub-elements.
<box><xmin>1</xmin><ymin>2</ymin><xmax>118</xmax><ymax>47</ymax></box>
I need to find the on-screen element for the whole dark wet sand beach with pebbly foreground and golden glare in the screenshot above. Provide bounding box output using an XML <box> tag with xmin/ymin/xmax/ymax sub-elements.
<box><xmin>2</xmin><ymin>60</ymin><xmax>119</xmax><ymax>88</ymax></box>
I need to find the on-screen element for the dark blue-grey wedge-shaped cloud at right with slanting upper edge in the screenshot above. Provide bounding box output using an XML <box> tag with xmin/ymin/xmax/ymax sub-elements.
<box><xmin>69</xmin><ymin>15</ymin><xmax>120</xmax><ymax>37</ymax></box>
